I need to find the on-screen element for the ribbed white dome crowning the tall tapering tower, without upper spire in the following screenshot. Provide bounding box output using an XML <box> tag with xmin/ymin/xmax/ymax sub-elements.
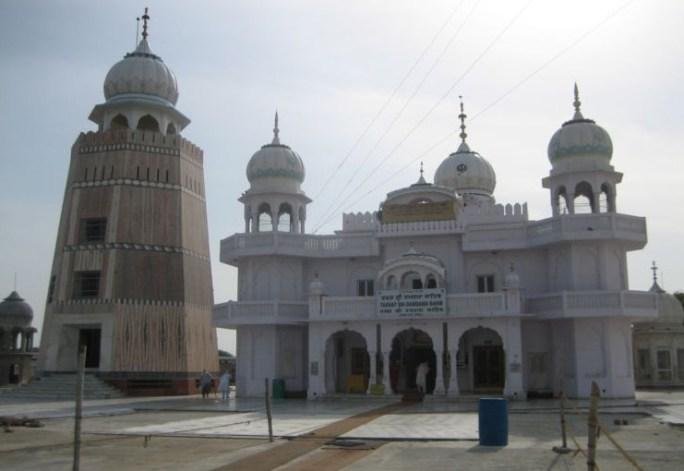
<box><xmin>104</xmin><ymin>38</ymin><xmax>178</xmax><ymax>105</ymax></box>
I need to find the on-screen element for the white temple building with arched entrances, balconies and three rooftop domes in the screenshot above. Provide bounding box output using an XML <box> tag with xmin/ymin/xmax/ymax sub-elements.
<box><xmin>214</xmin><ymin>88</ymin><xmax>659</xmax><ymax>399</ymax></box>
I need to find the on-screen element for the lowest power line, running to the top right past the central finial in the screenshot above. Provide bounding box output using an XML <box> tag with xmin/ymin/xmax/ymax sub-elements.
<box><xmin>316</xmin><ymin>0</ymin><xmax>636</xmax><ymax>234</ymax></box>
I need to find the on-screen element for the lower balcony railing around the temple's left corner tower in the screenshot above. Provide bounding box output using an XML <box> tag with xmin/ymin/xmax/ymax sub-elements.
<box><xmin>213</xmin><ymin>301</ymin><xmax>309</xmax><ymax>327</ymax></box>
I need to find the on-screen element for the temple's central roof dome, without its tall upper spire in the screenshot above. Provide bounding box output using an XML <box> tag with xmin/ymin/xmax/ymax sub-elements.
<box><xmin>435</xmin><ymin>142</ymin><xmax>496</xmax><ymax>196</ymax></box>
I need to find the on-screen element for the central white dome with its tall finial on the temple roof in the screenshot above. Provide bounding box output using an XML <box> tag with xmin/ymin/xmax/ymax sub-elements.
<box><xmin>435</xmin><ymin>98</ymin><xmax>496</xmax><ymax>207</ymax></box>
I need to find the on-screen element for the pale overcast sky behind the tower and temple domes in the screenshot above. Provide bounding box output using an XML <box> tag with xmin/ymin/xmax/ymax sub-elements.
<box><xmin>0</xmin><ymin>0</ymin><xmax>684</xmax><ymax>351</ymax></box>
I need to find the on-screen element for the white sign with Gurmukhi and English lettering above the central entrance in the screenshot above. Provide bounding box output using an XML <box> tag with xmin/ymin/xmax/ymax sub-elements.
<box><xmin>378</xmin><ymin>288</ymin><xmax>446</xmax><ymax>317</ymax></box>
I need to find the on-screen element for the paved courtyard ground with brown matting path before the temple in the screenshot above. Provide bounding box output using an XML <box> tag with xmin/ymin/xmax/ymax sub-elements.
<box><xmin>0</xmin><ymin>391</ymin><xmax>684</xmax><ymax>471</ymax></box>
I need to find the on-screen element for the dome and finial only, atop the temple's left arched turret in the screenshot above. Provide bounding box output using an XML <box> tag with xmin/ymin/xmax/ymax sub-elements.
<box><xmin>247</xmin><ymin>113</ymin><xmax>305</xmax><ymax>191</ymax></box>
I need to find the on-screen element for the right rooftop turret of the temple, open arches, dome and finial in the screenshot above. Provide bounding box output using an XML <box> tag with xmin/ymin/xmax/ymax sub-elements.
<box><xmin>542</xmin><ymin>84</ymin><xmax>622</xmax><ymax>216</ymax></box>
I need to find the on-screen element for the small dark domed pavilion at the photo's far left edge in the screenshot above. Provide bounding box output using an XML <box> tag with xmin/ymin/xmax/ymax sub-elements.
<box><xmin>0</xmin><ymin>291</ymin><xmax>36</xmax><ymax>386</ymax></box>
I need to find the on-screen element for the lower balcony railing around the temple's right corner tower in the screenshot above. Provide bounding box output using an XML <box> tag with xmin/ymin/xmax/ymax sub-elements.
<box><xmin>526</xmin><ymin>291</ymin><xmax>658</xmax><ymax>317</ymax></box>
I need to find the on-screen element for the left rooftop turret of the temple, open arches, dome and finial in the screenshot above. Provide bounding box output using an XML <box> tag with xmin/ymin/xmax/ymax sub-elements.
<box><xmin>239</xmin><ymin>111</ymin><xmax>311</xmax><ymax>233</ymax></box>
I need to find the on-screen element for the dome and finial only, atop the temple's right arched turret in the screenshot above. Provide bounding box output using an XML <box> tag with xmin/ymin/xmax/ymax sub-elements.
<box><xmin>548</xmin><ymin>85</ymin><xmax>613</xmax><ymax>165</ymax></box>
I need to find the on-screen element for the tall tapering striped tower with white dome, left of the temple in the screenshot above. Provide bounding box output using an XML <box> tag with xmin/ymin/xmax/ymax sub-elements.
<box><xmin>39</xmin><ymin>9</ymin><xmax>218</xmax><ymax>394</ymax></box>
